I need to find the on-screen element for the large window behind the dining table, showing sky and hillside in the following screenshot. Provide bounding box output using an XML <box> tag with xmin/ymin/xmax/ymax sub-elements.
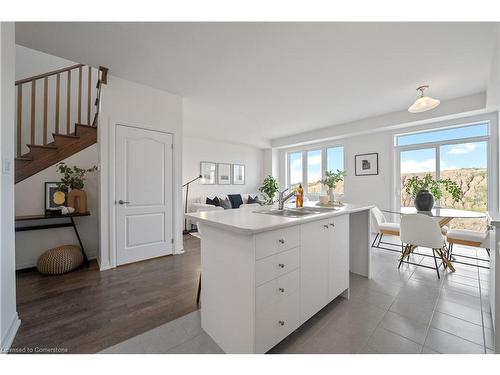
<box><xmin>396</xmin><ymin>123</ymin><xmax>489</xmax><ymax>230</ymax></box>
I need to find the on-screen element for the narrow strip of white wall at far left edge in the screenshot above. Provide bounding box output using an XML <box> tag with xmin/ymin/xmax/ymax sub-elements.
<box><xmin>0</xmin><ymin>22</ymin><xmax>20</xmax><ymax>351</ymax></box>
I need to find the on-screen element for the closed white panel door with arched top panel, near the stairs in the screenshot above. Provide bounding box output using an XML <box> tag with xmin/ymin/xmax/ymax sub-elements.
<box><xmin>115</xmin><ymin>126</ymin><xmax>173</xmax><ymax>265</ymax></box>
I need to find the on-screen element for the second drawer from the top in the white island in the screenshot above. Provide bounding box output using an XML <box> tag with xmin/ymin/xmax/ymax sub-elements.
<box><xmin>255</xmin><ymin>247</ymin><xmax>299</xmax><ymax>286</ymax></box>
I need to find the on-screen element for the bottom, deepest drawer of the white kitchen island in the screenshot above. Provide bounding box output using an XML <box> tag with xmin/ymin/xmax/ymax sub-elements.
<box><xmin>255</xmin><ymin>291</ymin><xmax>300</xmax><ymax>353</ymax></box>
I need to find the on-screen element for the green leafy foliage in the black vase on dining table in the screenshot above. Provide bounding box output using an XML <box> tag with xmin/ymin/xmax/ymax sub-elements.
<box><xmin>404</xmin><ymin>173</ymin><xmax>463</xmax><ymax>203</ymax></box>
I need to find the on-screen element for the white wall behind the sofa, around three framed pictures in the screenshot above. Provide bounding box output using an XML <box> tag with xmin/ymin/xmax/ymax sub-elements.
<box><xmin>182</xmin><ymin>136</ymin><xmax>264</xmax><ymax>200</ymax></box>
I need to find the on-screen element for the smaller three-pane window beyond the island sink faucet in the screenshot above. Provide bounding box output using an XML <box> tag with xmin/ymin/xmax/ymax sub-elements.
<box><xmin>287</xmin><ymin>146</ymin><xmax>344</xmax><ymax>196</ymax></box>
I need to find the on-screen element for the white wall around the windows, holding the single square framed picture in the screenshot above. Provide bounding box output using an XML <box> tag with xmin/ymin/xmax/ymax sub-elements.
<box><xmin>279</xmin><ymin>113</ymin><xmax>498</xmax><ymax>216</ymax></box>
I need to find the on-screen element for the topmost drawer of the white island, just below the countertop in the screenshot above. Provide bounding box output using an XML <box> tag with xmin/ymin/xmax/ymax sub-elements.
<box><xmin>255</xmin><ymin>226</ymin><xmax>299</xmax><ymax>259</ymax></box>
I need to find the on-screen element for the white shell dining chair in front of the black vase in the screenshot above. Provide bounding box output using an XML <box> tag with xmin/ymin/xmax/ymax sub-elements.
<box><xmin>398</xmin><ymin>214</ymin><xmax>447</xmax><ymax>279</ymax></box>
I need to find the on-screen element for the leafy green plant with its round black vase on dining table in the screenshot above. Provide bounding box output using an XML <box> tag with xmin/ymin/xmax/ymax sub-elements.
<box><xmin>404</xmin><ymin>173</ymin><xmax>463</xmax><ymax>211</ymax></box>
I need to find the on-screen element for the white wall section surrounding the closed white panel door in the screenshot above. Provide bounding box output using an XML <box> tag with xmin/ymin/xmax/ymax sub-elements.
<box><xmin>98</xmin><ymin>76</ymin><xmax>183</xmax><ymax>269</ymax></box>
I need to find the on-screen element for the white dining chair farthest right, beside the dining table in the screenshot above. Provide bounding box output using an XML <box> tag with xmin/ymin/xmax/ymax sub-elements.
<box><xmin>446</xmin><ymin>229</ymin><xmax>490</xmax><ymax>269</ymax></box>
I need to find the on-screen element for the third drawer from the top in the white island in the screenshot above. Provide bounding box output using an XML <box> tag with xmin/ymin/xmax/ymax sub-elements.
<box><xmin>255</xmin><ymin>269</ymin><xmax>300</xmax><ymax>314</ymax></box>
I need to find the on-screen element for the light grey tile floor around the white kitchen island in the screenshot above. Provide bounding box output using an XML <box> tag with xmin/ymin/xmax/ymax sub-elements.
<box><xmin>102</xmin><ymin>241</ymin><xmax>494</xmax><ymax>354</ymax></box>
